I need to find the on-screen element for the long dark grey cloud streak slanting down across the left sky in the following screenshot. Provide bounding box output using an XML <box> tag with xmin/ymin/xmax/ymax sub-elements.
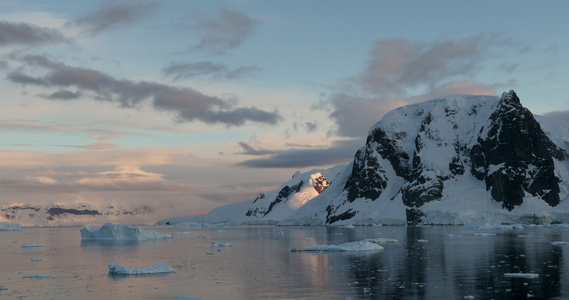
<box><xmin>6</xmin><ymin>55</ymin><xmax>282</xmax><ymax>126</ymax></box>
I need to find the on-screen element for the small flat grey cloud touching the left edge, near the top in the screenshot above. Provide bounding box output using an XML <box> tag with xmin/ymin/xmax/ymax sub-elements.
<box><xmin>0</xmin><ymin>21</ymin><xmax>71</xmax><ymax>47</ymax></box>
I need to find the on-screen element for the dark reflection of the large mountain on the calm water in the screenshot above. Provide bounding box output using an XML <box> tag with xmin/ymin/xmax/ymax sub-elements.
<box><xmin>328</xmin><ymin>227</ymin><xmax>566</xmax><ymax>299</ymax></box>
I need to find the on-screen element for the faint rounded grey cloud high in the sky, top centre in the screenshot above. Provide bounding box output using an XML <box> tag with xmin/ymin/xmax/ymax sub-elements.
<box><xmin>193</xmin><ymin>8</ymin><xmax>257</xmax><ymax>54</ymax></box>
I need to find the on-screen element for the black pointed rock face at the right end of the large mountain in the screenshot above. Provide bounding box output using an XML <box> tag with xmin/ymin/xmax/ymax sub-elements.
<box><xmin>470</xmin><ymin>91</ymin><xmax>565</xmax><ymax>211</ymax></box>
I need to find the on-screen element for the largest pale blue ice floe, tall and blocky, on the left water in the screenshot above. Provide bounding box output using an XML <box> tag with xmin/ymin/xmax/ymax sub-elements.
<box><xmin>81</xmin><ymin>223</ymin><xmax>172</xmax><ymax>240</ymax></box>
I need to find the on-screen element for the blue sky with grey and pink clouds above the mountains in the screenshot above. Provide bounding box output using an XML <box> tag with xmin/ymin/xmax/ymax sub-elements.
<box><xmin>0</xmin><ymin>0</ymin><xmax>569</xmax><ymax>223</ymax></box>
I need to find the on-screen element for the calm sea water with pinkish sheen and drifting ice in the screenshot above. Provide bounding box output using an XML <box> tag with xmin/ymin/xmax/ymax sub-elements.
<box><xmin>0</xmin><ymin>226</ymin><xmax>569</xmax><ymax>299</ymax></box>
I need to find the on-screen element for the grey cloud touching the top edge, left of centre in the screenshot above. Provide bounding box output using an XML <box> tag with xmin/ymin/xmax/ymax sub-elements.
<box><xmin>67</xmin><ymin>0</ymin><xmax>158</xmax><ymax>36</ymax></box>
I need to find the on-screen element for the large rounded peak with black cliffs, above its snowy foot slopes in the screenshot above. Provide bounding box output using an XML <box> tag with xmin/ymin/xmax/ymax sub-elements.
<box><xmin>326</xmin><ymin>90</ymin><xmax>566</xmax><ymax>225</ymax></box>
